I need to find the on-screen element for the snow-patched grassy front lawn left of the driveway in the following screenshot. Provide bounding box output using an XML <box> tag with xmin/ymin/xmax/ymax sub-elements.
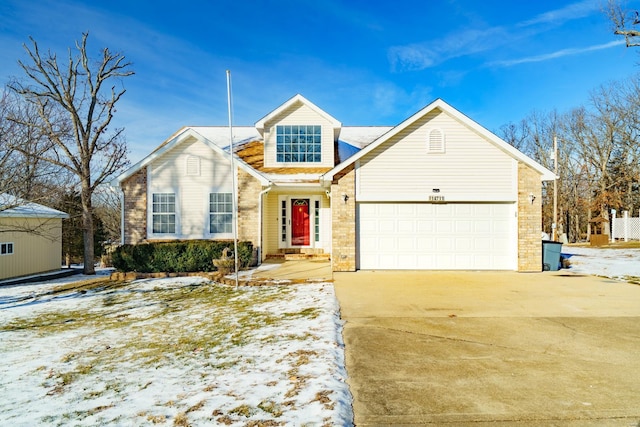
<box><xmin>0</xmin><ymin>278</ymin><xmax>352</xmax><ymax>426</ymax></box>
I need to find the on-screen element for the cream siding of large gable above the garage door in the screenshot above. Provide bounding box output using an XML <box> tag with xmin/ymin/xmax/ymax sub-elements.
<box><xmin>356</xmin><ymin>110</ymin><xmax>518</xmax><ymax>202</ymax></box>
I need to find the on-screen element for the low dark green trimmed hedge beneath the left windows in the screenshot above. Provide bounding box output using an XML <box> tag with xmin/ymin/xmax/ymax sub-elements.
<box><xmin>112</xmin><ymin>240</ymin><xmax>253</xmax><ymax>273</ymax></box>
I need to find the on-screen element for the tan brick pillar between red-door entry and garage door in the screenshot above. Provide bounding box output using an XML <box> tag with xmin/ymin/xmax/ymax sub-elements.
<box><xmin>331</xmin><ymin>166</ymin><xmax>356</xmax><ymax>271</ymax></box>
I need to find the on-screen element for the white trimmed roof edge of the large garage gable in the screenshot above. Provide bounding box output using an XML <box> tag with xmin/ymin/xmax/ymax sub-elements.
<box><xmin>321</xmin><ymin>98</ymin><xmax>556</xmax><ymax>182</ymax></box>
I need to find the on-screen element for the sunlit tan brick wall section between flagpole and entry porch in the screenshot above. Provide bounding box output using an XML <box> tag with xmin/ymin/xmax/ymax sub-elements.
<box><xmin>238</xmin><ymin>169</ymin><xmax>262</xmax><ymax>260</ymax></box>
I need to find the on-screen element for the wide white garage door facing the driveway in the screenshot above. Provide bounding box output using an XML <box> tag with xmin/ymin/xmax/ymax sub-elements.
<box><xmin>358</xmin><ymin>203</ymin><xmax>517</xmax><ymax>270</ymax></box>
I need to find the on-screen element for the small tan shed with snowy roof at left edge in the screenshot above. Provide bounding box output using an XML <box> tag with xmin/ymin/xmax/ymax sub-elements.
<box><xmin>0</xmin><ymin>194</ymin><xmax>69</xmax><ymax>280</ymax></box>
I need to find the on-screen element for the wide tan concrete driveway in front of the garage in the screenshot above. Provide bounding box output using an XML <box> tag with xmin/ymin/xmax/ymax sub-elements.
<box><xmin>334</xmin><ymin>271</ymin><xmax>640</xmax><ymax>426</ymax></box>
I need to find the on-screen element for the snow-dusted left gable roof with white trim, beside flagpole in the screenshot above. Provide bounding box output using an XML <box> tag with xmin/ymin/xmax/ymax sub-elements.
<box><xmin>111</xmin><ymin>127</ymin><xmax>269</xmax><ymax>186</ymax></box>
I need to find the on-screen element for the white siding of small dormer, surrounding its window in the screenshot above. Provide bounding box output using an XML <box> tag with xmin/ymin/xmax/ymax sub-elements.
<box><xmin>264</xmin><ymin>104</ymin><xmax>334</xmax><ymax>168</ymax></box>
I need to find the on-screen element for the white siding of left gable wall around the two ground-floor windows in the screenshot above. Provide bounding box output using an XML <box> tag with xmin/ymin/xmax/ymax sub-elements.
<box><xmin>147</xmin><ymin>139</ymin><xmax>232</xmax><ymax>239</ymax></box>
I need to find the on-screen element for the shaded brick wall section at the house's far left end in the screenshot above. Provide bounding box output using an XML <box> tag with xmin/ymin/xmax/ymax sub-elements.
<box><xmin>122</xmin><ymin>168</ymin><xmax>147</xmax><ymax>245</ymax></box>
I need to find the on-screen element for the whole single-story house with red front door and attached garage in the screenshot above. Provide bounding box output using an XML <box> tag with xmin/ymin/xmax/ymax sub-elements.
<box><xmin>113</xmin><ymin>95</ymin><xmax>554</xmax><ymax>271</ymax></box>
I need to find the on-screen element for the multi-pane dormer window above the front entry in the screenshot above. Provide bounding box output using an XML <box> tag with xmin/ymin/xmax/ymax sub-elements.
<box><xmin>276</xmin><ymin>125</ymin><xmax>322</xmax><ymax>163</ymax></box>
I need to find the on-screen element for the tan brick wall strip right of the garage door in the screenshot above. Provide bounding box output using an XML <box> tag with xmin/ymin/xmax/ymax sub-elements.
<box><xmin>518</xmin><ymin>163</ymin><xmax>542</xmax><ymax>272</ymax></box>
